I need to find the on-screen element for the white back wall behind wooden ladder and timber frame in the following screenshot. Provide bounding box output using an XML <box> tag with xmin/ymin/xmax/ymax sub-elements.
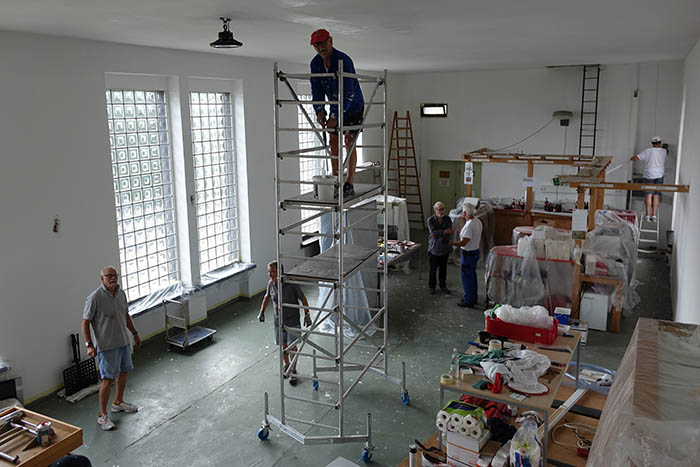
<box><xmin>389</xmin><ymin>62</ymin><xmax>682</xmax><ymax>241</ymax></box>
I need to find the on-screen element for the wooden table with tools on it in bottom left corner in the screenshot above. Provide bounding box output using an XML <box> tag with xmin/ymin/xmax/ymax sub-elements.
<box><xmin>0</xmin><ymin>407</ymin><xmax>83</xmax><ymax>467</ymax></box>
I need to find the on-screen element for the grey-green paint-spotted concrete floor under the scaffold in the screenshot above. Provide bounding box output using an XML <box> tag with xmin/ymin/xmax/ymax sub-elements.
<box><xmin>29</xmin><ymin>231</ymin><xmax>671</xmax><ymax>467</ymax></box>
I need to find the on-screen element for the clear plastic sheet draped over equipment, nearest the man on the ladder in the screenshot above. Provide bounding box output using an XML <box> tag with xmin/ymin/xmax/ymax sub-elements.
<box><xmin>583</xmin><ymin>217</ymin><xmax>640</xmax><ymax>316</ymax></box>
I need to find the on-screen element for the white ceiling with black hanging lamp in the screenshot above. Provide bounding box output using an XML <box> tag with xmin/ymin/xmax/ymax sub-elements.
<box><xmin>0</xmin><ymin>0</ymin><xmax>700</xmax><ymax>71</ymax></box>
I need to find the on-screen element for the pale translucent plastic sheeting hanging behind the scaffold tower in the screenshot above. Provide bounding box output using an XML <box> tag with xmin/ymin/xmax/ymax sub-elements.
<box><xmin>316</xmin><ymin>213</ymin><xmax>374</xmax><ymax>337</ymax></box>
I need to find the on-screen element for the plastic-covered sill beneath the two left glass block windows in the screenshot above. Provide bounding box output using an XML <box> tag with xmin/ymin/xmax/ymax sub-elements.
<box><xmin>129</xmin><ymin>262</ymin><xmax>257</xmax><ymax>318</ymax></box>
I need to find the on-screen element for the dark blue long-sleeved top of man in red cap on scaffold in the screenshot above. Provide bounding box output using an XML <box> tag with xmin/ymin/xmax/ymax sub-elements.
<box><xmin>311</xmin><ymin>48</ymin><xmax>365</xmax><ymax>120</ymax></box>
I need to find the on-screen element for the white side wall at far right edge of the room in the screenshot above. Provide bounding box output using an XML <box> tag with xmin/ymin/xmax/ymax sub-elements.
<box><xmin>671</xmin><ymin>37</ymin><xmax>700</xmax><ymax>324</ymax></box>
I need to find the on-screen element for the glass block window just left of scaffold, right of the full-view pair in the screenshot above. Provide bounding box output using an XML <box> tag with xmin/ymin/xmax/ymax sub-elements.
<box><xmin>190</xmin><ymin>92</ymin><xmax>240</xmax><ymax>274</ymax></box>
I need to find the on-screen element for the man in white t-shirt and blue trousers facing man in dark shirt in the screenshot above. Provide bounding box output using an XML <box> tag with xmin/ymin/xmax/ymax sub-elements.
<box><xmin>450</xmin><ymin>203</ymin><xmax>483</xmax><ymax>307</ymax></box>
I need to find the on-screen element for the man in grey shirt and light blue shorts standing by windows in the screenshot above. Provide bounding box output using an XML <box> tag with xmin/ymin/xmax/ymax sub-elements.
<box><xmin>82</xmin><ymin>266</ymin><xmax>141</xmax><ymax>430</ymax></box>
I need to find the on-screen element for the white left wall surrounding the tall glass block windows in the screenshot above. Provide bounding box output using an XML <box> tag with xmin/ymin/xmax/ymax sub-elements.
<box><xmin>0</xmin><ymin>32</ymin><xmax>275</xmax><ymax>398</ymax></box>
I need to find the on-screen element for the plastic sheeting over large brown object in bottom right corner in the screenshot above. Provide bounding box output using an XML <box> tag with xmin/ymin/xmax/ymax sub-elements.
<box><xmin>587</xmin><ymin>318</ymin><xmax>700</xmax><ymax>467</ymax></box>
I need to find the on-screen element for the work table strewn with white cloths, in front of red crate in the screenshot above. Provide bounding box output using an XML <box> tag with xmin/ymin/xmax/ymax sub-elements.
<box><xmin>438</xmin><ymin>331</ymin><xmax>581</xmax><ymax>459</ymax></box>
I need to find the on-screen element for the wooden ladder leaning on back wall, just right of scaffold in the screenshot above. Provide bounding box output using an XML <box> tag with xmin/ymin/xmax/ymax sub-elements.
<box><xmin>387</xmin><ymin>111</ymin><xmax>425</xmax><ymax>229</ymax></box>
